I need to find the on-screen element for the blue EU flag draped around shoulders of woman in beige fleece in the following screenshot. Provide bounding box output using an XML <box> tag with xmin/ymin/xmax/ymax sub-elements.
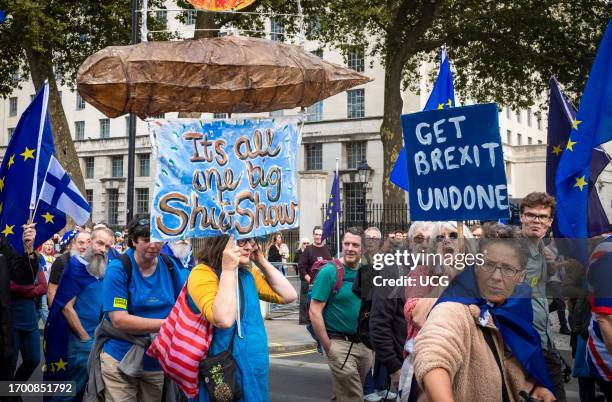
<box><xmin>435</xmin><ymin>267</ymin><xmax>554</xmax><ymax>393</ymax></box>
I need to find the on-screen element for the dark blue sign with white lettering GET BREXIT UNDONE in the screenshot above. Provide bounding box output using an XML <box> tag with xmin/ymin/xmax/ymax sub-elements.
<box><xmin>402</xmin><ymin>103</ymin><xmax>509</xmax><ymax>221</ymax></box>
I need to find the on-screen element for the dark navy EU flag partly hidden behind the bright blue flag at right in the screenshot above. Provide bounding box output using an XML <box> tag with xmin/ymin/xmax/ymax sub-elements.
<box><xmin>546</xmin><ymin>77</ymin><xmax>610</xmax><ymax>238</ymax></box>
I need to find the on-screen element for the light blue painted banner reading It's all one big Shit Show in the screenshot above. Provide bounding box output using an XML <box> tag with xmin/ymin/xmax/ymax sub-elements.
<box><xmin>149</xmin><ymin>117</ymin><xmax>299</xmax><ymax>241</ymax></box>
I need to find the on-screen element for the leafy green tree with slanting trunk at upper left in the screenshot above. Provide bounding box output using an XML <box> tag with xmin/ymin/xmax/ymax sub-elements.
<box><xmin>0</xmin><ymin>0</ymin><xmax>167</xmax><ymax>192</ymax></box>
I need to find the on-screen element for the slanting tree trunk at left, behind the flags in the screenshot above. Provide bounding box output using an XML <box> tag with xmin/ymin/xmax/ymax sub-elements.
<box><xmin>24</xmin><ymin>44</ymin><xmax>85</xmax><ymax>195</ymax></box>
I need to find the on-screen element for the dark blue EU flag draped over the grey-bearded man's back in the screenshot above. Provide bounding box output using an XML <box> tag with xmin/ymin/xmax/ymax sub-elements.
<box><xmin>43</xmin><ymin>256</ymin><xmax>97</xmax><ymax>384</ymax></box>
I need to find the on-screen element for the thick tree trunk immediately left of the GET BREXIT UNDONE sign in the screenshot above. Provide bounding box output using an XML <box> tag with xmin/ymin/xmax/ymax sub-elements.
<box><xmin>380</xmin><ymin>52</ymin><xmax>406</xmax><ymax>205</ymax></box>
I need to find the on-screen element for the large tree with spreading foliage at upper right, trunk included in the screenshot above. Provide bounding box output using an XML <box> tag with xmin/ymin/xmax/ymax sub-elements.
<box><xmin>293</xmin><ymin>0</ymin><xmax>612</xmax><ymax>203</ymax></box>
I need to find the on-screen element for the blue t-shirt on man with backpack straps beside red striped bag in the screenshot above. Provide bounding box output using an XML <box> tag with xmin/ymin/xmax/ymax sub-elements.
<box><xmin>103</xmin><ymin>249</ymin><xmax>186</xmax><ymax>371</ymax></box>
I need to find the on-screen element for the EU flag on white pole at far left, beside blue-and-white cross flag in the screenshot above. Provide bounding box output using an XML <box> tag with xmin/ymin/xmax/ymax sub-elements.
<box><xmin>0</xmin><ymin>84</ymin><xmax>66</xmax><ymax>253</ymax></box>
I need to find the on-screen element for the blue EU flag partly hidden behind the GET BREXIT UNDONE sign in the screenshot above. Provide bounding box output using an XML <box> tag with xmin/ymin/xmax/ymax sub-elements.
<box><xmin>390</xmin><ymin>49</ymin><xmax>455</xmax><ymax>191</ymax></box>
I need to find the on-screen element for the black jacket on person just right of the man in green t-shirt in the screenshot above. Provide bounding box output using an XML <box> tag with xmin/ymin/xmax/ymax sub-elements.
<box><xmin>370</xmin><ymin>267</ymin><xmax>408</xmax><ymax>374</ymax></box>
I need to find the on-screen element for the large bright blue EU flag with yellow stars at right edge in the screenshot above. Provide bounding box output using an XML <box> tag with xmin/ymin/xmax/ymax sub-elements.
<box><xmin>555</xmin><ymin>20</ymin><xmax>612</xmax><ymax>238</ymax></box>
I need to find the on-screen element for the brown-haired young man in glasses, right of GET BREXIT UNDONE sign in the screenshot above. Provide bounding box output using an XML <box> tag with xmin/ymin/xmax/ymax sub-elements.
<box><xmin>520</xmin><ymin>192</ymin><xmax>567</xmax><ymax>402</ymax></box>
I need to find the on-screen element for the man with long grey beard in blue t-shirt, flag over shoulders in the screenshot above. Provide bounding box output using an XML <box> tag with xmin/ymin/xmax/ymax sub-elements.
<box><xmin>45</xmin><ymin>227</ymin><xmax>114</xmax><ymax>400</ymax></box>
